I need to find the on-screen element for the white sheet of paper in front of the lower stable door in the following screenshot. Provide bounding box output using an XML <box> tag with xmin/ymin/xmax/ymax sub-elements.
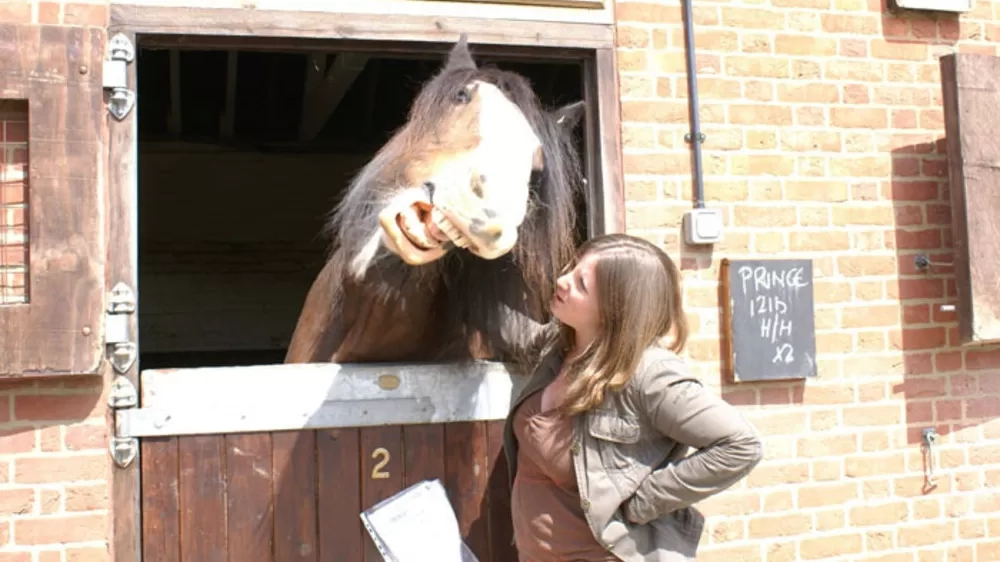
<box><xmin>361</xmin><ymin>479</ymin><xmax>479</xmax><ymax>562</ymax></box>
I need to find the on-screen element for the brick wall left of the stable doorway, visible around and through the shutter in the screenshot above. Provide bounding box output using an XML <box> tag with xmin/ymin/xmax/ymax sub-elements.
<box><xmin>0</xmin><ymin>4</ymin><xmax>111</xmax><ymax>562</ymax></box>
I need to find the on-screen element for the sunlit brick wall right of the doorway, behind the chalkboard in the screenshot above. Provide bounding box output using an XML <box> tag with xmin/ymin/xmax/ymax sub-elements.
<box><xmin>617</xmin><ymin>0</ymin><xmax>1000</xmax><ymax>562</ymax></box>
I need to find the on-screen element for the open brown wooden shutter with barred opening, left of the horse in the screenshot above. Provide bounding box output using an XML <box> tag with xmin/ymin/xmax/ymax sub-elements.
<box><xmin>0</xmin><ymin>24</ymin><xmax>107</xmax><ymax>378</ymax></box>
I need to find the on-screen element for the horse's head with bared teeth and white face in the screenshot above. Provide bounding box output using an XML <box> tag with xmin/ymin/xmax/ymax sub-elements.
<box><xmin>334</xmin><ymin>34</ymin><xmax>583</xmax><ymax>278</ymax></box>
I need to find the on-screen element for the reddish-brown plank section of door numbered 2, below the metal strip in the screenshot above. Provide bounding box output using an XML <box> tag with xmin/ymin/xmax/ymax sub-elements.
<box><xmin>142</xmin><ymin>421</ymin><xmax>517</xmax><ymax>562</ymax></box>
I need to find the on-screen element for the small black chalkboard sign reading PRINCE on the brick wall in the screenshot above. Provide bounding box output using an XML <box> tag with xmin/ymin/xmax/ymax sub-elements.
<box><xmin>722</xmin><ymin>259</ymin><xmax>816</xmax><ymax>381</ymax></box>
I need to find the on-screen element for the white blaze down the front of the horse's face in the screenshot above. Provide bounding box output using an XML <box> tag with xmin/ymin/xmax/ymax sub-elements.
<box><xmin>433</xmin><ymin>82</ymin><xmax>541</xmax><ymax>259</ymax></box>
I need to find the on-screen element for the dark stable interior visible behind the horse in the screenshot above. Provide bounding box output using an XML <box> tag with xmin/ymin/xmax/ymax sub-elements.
<box><xmin>136</xmin><ymin>44</ymin><xmax>587</xmax><ymax>369</ymax></box>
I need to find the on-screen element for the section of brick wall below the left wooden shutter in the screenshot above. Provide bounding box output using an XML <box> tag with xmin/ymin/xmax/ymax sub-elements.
<box><xmin>0</xmin><ymin>376</ymin><xmax>111</xmax><ymax>562</ymax></box>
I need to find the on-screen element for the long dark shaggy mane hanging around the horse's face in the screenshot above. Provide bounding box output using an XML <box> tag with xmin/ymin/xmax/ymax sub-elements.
<box><xmin>316</xmin><ymin>51</ymin><xmax>582</xmax><ymax>358</ymax></box>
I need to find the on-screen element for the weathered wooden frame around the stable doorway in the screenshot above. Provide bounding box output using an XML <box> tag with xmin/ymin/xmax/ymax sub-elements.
<box><xmin>107</xmin><ymin>5</ymin><xmax>625</xmax><ymax>562</ymax></box>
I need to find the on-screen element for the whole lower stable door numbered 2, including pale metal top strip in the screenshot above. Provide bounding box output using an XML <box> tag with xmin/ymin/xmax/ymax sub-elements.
<box><xmin>128</xmin><ymin>363</ymin><xmax>517</xmax><ymax>562</ymax></box>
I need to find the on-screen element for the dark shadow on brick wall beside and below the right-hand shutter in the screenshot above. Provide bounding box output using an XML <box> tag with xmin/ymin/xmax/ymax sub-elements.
<box><xmin>886</xmin><ymin>138</ymin><xmax>1000</xmax><ymax>458</ymax></box>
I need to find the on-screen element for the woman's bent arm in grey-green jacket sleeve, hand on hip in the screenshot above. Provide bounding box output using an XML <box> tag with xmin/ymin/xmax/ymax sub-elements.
<box><xmin>625</xmin><ymin>370</ymin><xmax>763</xmax><ymax>524</ymax></box>
